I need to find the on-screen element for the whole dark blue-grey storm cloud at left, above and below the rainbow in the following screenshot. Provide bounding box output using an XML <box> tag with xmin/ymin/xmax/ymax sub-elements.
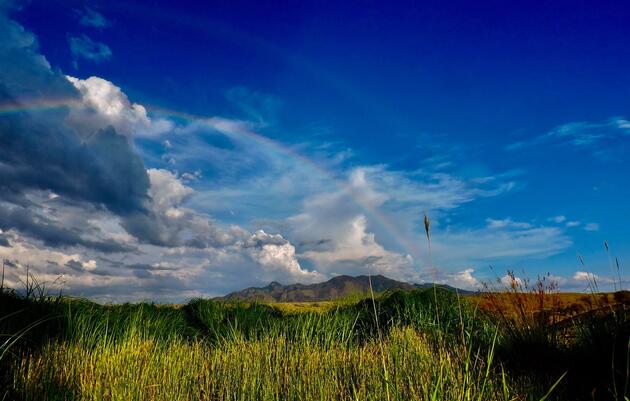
<box><xmin>0</xmin><ymin>17</ymin><xmax>149</xmax><ymax>219</ymax></box>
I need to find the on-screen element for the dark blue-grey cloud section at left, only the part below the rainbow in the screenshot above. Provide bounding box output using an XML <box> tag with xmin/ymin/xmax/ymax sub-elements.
<box><xmin>0</xmin><ymin>115</ymin><xmax>154</xmax><ymax>219</ymax></box>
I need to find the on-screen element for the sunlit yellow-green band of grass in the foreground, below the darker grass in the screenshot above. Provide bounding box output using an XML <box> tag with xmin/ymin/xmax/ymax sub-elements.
<box><xmin>13</xmin><ymin>328</ymin><xmax>515</xmax><ymax>401</ymax></box>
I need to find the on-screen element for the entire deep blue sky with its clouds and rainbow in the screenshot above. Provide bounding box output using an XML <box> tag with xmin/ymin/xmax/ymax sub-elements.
<box><xmin>0</xmin><ymin>0</ymin><xmax>630</xmax><ymax>302</ymax></box>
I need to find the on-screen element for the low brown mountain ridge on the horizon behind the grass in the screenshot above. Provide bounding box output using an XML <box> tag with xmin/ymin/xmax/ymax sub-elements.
<box><xmin>215</xmin><ymin>275</ymin><xmax>472</xmax><ymax>302</ymax></box>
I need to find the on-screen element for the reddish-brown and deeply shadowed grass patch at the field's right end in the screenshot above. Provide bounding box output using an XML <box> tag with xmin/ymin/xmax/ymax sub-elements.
<box><xmin>473</xmin><ymin>272</ymin><xmax>630</xmax><ymax>401</ymax></box>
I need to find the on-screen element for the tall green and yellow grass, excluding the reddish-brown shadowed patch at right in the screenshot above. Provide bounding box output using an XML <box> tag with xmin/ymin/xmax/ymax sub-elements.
<box><xmin>3</xmin><ymin>290</ymin><xmax>544</xmax><ymax>400</ymax></box>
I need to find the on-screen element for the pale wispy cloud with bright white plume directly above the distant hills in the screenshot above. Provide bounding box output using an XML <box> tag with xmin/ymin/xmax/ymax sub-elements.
<box><xmin>188</xmin><ymin>159</ymin><xmax>523</xmax><ymax>281</ymax></box>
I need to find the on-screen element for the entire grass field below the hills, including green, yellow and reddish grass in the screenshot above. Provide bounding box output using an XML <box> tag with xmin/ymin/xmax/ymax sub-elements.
<box><xmin>0</xmin><ymin>280</ymin><xmax>630</xmax><ymax>401</ymax></box>
